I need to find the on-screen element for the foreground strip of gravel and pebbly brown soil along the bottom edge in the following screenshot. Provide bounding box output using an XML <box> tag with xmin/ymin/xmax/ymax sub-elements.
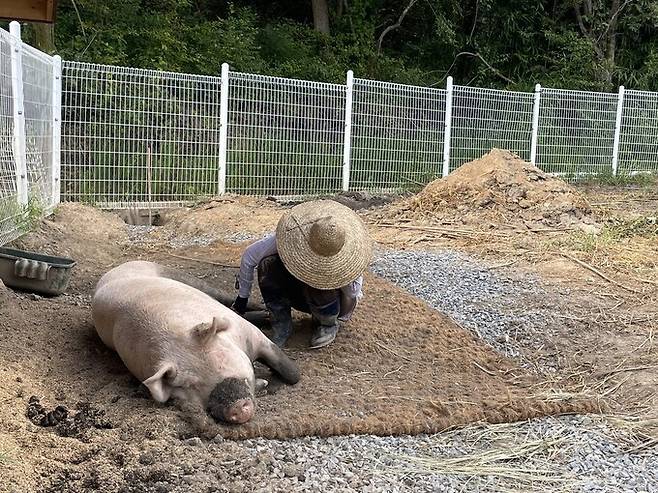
<box><xmin>56</xmin><ymin>416</ymin><xmax>658</xmax><ymax>493</ymax></box>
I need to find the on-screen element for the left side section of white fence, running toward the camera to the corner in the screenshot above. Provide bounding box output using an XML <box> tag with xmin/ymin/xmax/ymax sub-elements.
<box><xmin>0</xmin><ymin>22</ymin><xmax>61</xmax><ymax>245</ymax></box>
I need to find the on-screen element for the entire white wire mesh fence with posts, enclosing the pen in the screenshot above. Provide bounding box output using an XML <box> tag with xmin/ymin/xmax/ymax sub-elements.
<box><xmin>0</xmin><ymin>23</ymin><xmax>658</xmax><ymax>244</ymax></box>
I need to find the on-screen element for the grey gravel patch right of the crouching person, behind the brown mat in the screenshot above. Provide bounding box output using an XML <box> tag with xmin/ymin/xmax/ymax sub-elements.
<box><xmin>365</xmin><ymin>251</ymin><xmax>580</xmax><ymax>371</ymax></box>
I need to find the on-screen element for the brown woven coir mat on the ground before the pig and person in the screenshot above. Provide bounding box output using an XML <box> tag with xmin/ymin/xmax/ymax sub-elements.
<box><xmin>206</xmin><ymin>275</ymin><xmax>600</xmax><ymax>438</ymax></box>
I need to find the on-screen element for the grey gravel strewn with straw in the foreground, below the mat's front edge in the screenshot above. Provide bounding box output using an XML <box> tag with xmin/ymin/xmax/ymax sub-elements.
<box><xmin>222</xmin><ymin>416</ymin><xmax>658</xmax><ymax>493</ymax></box>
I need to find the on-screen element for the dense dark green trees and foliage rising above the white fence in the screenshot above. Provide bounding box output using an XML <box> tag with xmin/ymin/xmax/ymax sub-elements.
<box><xmin>2</xmin><ymin>0</ymin><xmax>658</xmax><ymax>91</ymax></box>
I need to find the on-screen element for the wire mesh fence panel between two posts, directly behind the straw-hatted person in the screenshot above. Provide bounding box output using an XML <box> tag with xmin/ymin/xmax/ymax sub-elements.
<box><xmin>226</xmin><ymin>72</ymin><xmax>346</xmax><ymax>197</ymax></box>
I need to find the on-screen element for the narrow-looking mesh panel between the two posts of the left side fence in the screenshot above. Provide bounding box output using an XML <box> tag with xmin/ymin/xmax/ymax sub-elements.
<box><xmin>22</xmin><ymin>44</ymin><xmax>53</xmax><ymax>208</ymax></box>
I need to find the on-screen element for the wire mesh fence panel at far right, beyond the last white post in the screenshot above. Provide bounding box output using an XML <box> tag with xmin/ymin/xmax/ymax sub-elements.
<box><xmin>617</xmin><ymin>91</ymin><xmax>658</xmax><ymax>175</ymax></box>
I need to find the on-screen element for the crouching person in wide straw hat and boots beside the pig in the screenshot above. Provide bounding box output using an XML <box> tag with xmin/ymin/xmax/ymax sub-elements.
<box><xmin>232</xmin><ymin>200</ymin><xmax>372</xmax><ymax>349</ymax></box>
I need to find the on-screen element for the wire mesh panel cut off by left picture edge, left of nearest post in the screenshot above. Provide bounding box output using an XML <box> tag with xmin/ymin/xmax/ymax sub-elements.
<box><xmin>0</xmin><ymin>29</ymin><xmax>22</xmax><ymax>245</ymax></box>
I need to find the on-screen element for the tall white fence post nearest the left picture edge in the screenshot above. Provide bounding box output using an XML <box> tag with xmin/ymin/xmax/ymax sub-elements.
<box><xmin>9</xmin><ymin>21</ymin><xmax>28</xmax><ymax>205</ymax></box>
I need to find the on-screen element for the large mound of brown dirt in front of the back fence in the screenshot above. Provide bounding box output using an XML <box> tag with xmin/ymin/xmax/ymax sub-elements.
<box><xmin>374</xmin><ymin>149</ymin><xmax>595</xmax><ymax>229</ymax></box>
